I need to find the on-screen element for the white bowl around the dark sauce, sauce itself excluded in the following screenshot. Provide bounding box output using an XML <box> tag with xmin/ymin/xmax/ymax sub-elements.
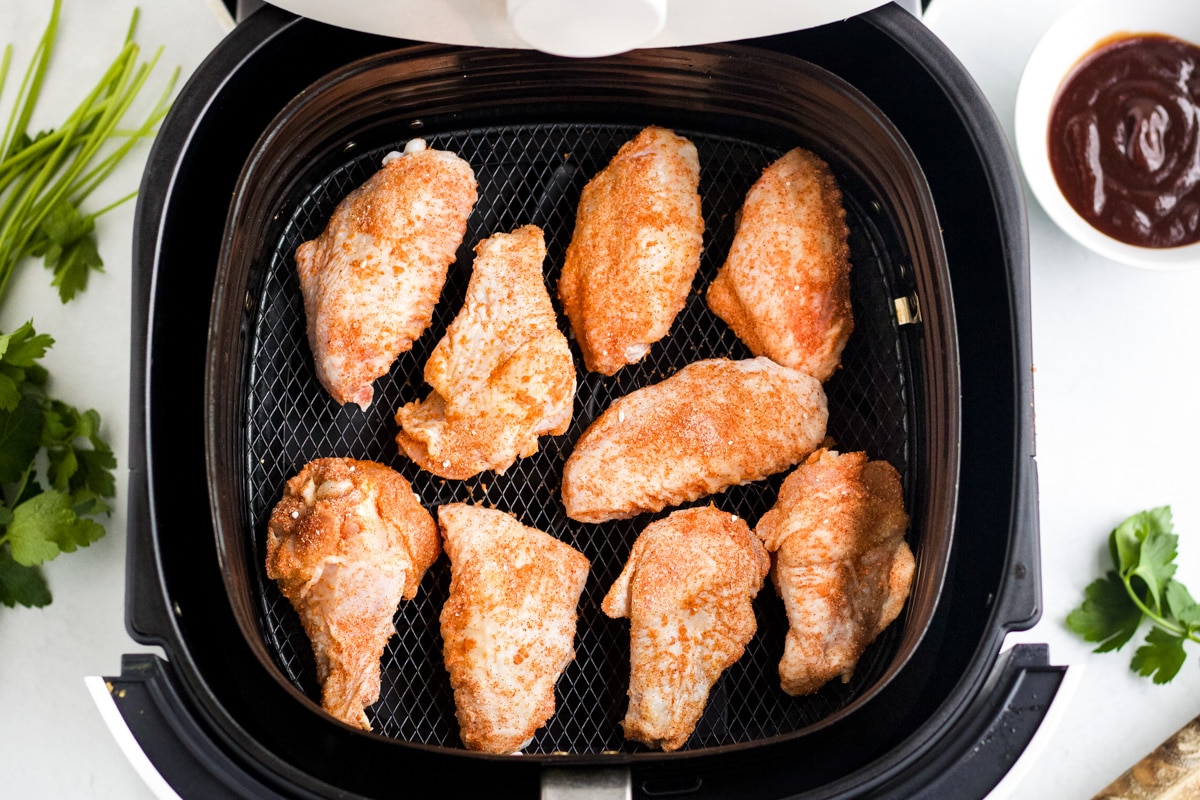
<box><xmin>1014</xmin><ymin>0</ymin><xmax>1200</xmax><ymax>270</ymax></box>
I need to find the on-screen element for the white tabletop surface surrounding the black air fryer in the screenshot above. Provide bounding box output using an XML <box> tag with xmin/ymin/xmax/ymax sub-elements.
<box><xmin>0</xmin><ymin>0</ymin><xmax>1200</xmax><ymax>800</ymax></box>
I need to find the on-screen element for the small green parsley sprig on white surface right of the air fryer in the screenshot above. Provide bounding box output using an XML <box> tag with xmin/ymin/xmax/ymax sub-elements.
<box><xmin>1067</xmin><ymin>506</ymin><xmax>1200</xmax><ymax>684</ymax></box>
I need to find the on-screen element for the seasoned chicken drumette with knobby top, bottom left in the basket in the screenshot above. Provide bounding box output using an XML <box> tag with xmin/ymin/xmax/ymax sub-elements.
<box><xmin>266</xmin><ymin>458</ymin><xmax>442</xmax><ymax>730</ymax></box>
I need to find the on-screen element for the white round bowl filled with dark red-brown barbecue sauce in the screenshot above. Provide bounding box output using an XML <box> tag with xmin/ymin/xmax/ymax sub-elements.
<box><xmin>1015</xmin><ymin>0</ymin><xmax>1200</xmax><ymax>269</ymax></box>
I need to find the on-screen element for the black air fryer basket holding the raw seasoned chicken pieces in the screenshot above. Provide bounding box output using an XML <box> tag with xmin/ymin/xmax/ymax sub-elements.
<box><xmin>112</xmin><ymin>6</ymin><xmax>1061</xmax><ymax>798</ymax></box>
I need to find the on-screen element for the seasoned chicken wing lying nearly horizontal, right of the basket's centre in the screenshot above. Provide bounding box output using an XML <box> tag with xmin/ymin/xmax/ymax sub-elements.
<box><xmin>563</xmin><ymin>359</ymin><xmax>828</xmax><ymax>522</ymax></box>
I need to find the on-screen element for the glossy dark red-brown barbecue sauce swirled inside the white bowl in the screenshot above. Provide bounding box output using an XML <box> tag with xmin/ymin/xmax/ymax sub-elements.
<box><xmin>1049</xmin><ymin>35</ymin><xmax>1200</xmax><ymax>247</ymax></box>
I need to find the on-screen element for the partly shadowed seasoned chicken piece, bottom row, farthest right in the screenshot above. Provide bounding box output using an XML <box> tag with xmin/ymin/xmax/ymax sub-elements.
<box><xmin>755</xmin><ymin>450</ymin><xmax>914</xmax><ymax>694</ymax></box>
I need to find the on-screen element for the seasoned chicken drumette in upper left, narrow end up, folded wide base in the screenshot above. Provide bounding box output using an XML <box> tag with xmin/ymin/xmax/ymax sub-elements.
<box><xmin>396</xmin><ymin>225</ymin><xmax>575</xmax><ymax>479</ymax></box>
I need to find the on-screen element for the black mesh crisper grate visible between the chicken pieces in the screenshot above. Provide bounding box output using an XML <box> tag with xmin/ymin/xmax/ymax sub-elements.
<box><xmin>246</xmin><ymin>125</ymin><xmax>919</xmax><ymax>753</ymax></box>
